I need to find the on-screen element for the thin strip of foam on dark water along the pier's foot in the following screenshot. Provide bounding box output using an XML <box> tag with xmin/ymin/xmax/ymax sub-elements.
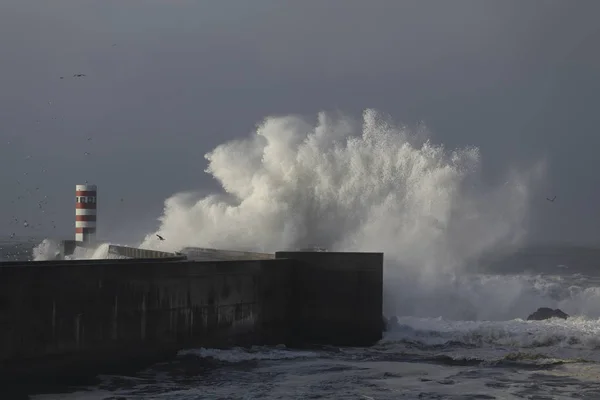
<box><xmin>178</xmin><ymin>346</ymin><xmax>319</xmax><ymax>363</ymax></box>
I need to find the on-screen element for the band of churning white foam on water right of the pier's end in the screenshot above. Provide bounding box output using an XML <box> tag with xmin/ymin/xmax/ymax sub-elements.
<box><xmin>382</xmin><ymin>317</ymin><xmax>600</xmax><ymax>349</ymax></box>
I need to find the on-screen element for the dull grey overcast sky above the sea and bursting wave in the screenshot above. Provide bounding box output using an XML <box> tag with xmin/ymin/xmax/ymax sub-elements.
<box><xmin>0</xmin><ymin>0</ymin><xmax>600</xmax><ymax>243</ymax></box>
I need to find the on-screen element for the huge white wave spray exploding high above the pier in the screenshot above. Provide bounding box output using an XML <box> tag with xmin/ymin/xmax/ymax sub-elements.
<box><xmin>141</xmin><ymin>110</ymin><xmax>543</xmax><ymax>316</ymax></box>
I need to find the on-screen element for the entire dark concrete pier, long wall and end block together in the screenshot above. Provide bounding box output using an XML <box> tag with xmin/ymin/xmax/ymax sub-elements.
<box><xmin>0</xmin><ymin>252</ymin><xmax>383</xmax><ymax>380</ymax></box>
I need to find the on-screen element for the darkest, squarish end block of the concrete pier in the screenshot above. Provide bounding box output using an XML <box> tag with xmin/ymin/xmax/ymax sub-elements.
<box><xmin>275</xmin><ymin>252</ymin><xmax>383</xmax><ymax>346</ymax></box>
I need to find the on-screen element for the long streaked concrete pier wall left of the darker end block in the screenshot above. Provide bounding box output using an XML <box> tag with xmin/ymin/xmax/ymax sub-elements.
<box><xmin>0</xmin><ymin>259</ymin><xmax>291</xmax><ymax>379</ymax></box>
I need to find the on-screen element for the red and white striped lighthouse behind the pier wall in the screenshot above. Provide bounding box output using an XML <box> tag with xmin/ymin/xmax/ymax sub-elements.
<box><xmin>75</xmin><ymin>185</ymin><xmax>97</xmax><ymax>243</ymax></box>
